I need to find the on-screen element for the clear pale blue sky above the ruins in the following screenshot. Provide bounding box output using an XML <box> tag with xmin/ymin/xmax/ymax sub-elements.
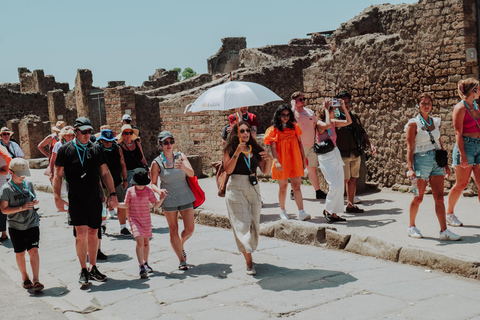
<box><xmin>0</xmin><ymin>0</ymin><xmax>416</xmax><ymax>88</ymax></box>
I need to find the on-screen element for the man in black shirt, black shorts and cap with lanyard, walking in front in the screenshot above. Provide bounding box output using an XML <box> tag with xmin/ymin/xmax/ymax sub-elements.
<box><xmin>53</xmin><ymin>117</ymin><xmax>118</xmax><ymax>285</ymax></box>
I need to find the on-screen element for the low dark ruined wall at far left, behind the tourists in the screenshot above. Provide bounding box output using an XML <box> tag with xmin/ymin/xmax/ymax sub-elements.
<box><xmin>0</xmin><ymin>88</ymin><xmax>49</xmax><ymax>127</ymax></box>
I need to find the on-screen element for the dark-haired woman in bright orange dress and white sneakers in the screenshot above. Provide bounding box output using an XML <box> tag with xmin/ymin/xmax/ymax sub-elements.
<box><xmin>263</xmin><ymin>104</ymin><xmax>310</xmax><ymax>220</ymax></box>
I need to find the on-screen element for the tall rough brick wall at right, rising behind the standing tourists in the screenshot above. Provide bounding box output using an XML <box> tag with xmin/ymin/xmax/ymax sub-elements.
<box><xmin>304</xmin><ymin>0</ymin><xmax>478</xmax><ymax>187</ymax></box>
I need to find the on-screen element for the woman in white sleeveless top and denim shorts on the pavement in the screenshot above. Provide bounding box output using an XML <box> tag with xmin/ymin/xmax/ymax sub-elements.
<box><xmin>405</xmin><ymin>93</ymin><xmax>461</xmax><ymax>240</ymax></box>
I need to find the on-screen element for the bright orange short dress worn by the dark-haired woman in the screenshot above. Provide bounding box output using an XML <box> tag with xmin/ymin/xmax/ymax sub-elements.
<box><xmin>263</xmin><ymin>123</ymin><xmax>304</xmax><ymax>180</ymax></box>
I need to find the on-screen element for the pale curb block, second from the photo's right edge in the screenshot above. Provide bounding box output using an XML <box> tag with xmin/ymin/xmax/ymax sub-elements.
<box><xmin>345</xmin><ymin>235</ymin><xmax>401</xmax><ymax>262</ymax></box>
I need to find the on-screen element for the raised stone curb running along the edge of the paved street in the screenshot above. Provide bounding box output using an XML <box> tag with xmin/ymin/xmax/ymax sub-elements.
<box><xmin>34</xmin><ymin>184</ymin><xmax>480</xmax><ymax>279</ymax></box>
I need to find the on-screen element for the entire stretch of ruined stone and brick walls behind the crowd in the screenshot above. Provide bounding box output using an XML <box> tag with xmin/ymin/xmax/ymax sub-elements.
<box><xmin>0</xmin><ymin>0</ymin><xmax>479</xmax><ymax>187</ymax></box>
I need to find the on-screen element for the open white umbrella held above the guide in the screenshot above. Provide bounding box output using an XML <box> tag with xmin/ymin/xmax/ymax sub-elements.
<box><xmin>184</xmin><ymin>81</ymin><xmax>283</xmax><ymax>113</ymax></box>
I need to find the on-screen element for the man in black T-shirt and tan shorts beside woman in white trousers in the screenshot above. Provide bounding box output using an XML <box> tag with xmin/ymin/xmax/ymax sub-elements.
<box><xmin>335</xmin><ymin>91</ymin><xmax>377</xmax><ymax>213</ymax></box>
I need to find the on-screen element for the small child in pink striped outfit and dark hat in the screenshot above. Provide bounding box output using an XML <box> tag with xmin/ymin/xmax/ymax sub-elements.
<box><xmin>118</xmin><ymin>168</ymin><xmax>166</xmax><ymax>279</ymax></box>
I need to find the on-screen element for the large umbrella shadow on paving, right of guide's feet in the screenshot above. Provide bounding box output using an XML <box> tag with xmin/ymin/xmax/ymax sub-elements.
<box><xmin>254</xmin><ymin>263</ymin><xmax>357</xmax><ymax>292</ymax></box>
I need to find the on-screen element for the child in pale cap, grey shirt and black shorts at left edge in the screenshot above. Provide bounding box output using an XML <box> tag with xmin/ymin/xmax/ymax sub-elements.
<box><xmin>0</xmin><ymin>158</ymin><xmax>44</xmax><ymax>292</ymax></box>
